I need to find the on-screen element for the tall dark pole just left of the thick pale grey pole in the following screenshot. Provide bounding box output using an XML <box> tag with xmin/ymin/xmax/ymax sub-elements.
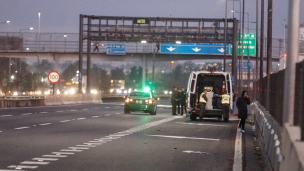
<box><xmin>266</xmin><ymin>0</ymin><xmax>272</xmax><ymax>111</ymax></box>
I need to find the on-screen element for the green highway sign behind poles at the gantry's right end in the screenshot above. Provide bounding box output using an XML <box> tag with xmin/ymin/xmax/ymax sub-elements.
<box><xmin>230</xmin><ymin>33</ymin><xmax>256</xmax><ymax>56</ymax></box>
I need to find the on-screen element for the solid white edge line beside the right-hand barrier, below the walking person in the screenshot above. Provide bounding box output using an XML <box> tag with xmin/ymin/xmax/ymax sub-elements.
<box><xmin>233</xmin><ymin>130</ymin><xmax>243</xmax><ymax>171</ymax></box>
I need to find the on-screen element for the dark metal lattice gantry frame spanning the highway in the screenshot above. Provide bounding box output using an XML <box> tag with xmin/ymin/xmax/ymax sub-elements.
<box><xmin>78</xmin><ymin>14</ymin><xmax>238</xmax><ymax>93</ymax></box>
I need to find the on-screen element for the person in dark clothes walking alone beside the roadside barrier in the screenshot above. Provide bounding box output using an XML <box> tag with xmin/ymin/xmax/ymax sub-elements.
<box><xmin>236</xmin><ymin>91</ymin><xmax>250</xmax><ymax>133</ymax></box>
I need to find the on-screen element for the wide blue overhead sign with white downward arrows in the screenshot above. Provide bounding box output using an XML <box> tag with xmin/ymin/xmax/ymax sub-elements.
<box><xmin>160</xmin><ymin>43</ymin><xmax>230</xmax><ymax>55</ymax></box>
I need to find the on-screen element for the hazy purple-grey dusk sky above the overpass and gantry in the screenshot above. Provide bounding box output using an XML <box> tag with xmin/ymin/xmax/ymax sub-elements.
<box><xmin>0</xmin><ymin>0</ymin><xmax>304</xmax><ymax>38</ymax></box>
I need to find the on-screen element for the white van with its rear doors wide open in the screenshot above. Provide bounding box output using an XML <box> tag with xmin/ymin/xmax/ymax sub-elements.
<box><xmin>187</xmin><ymin>71</ymin><xmax>233</xmax><ymax>120</ymax></box>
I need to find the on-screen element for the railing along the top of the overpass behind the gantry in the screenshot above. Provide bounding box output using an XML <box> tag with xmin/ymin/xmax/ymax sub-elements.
<box><xmin>0</xmin><ymin>32</ymin><xmax>283</xmax><ymax>57</ymax></box>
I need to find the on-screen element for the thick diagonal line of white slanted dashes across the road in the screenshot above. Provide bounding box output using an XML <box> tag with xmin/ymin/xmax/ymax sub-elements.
<box><xmin>0</xmin><ymin>114</ymin><xmax>178</xmax><ymax>171</ymax></box>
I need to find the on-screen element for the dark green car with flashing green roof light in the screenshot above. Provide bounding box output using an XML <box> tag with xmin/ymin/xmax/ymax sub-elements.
<box><xmin>124</xmin><ymin>91</ymin><xmax>157</xmax><ymax>115</ymax></box>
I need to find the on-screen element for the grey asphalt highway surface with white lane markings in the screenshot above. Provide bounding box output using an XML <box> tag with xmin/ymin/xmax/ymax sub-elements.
<box><xmin>0</xmin><ymin>101</ymin><xmax>238</xmax><ymax>171</ymax></box>
